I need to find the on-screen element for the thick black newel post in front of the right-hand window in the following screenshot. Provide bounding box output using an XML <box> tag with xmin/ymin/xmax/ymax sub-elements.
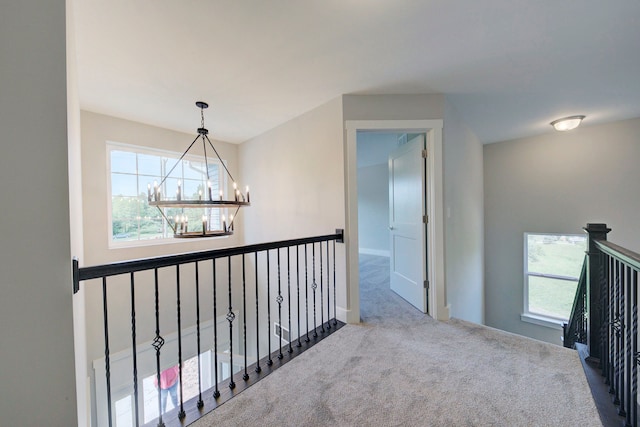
<box><xmin>584</xmin><ymin>224</ymin><xmax>611</xmax><ymax>359</ymax></box>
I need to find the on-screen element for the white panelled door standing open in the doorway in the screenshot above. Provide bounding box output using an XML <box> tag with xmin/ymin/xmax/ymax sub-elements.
<box><xmin>389</xmin><ymin>135</ymin><xmax>427</xmax><ymax>313</ymax></box>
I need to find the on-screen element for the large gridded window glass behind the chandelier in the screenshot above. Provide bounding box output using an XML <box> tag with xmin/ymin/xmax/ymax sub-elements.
<box><xmin>107</xmin><ymin>142</ymin><xmax>225</xmax><ymax>246</ymax></box>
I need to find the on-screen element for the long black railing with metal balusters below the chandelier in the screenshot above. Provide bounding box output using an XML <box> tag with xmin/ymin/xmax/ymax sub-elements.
<box><xmin>73</xmin><ymin>229</ymin><xmax>344</xmax><ymax>427</ymax></box>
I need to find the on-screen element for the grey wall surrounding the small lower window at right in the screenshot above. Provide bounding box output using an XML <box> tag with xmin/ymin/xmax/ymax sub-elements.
<box><xmin>484</xmin><ymin>119</ymin><xmax>640</xmax><ymax>344</ymax></box>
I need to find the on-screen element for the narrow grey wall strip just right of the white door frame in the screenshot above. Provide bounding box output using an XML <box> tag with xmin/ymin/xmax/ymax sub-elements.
<box><xmin>443</xmin><ymin>102</ymin><xmax>484</xmax><ymax>323</ymax></box>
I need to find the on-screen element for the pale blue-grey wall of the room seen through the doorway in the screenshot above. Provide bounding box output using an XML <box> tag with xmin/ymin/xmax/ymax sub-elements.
<box><xmin>358</xmin><ymin>163</ymin><xmax>390</xmax><ymax>256</ymax></box>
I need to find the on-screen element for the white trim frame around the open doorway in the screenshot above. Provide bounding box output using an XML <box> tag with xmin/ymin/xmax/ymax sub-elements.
<box><xmin>341</xmin><ymin>120</ymin><xmax>449</xmax><ymax>323</ymax></box>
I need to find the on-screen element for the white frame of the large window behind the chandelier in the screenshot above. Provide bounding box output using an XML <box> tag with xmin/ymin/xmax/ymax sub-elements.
<box><xmin>106</xmin><ymin>141</ymin><xmax>228</xmax><ymax>249</ymax></box>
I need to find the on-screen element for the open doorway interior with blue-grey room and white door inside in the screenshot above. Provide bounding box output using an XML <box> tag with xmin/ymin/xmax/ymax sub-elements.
<box><xmin>357</xmin><ymin>131</ymin><xmax>428</xmax><ymax>316</ymax></box>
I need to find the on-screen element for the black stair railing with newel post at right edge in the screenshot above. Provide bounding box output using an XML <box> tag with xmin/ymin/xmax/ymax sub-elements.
<box><xmin>570</xmin><ymin>224</ymin><xmax>640</xmax><ymax>426</ymax></box>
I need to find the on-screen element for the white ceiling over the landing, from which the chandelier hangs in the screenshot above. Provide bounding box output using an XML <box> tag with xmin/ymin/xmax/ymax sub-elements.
<box><xmin>73</xmin><ymin>0</ymin><xmax>640</xmax><ymax>143</ymax></box>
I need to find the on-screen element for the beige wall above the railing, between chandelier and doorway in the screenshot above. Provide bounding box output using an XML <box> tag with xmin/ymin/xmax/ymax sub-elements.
<box><xmin>238</xmin><ymin>98</ymin><xmax>346</xmax><ymax>320</ymax></box>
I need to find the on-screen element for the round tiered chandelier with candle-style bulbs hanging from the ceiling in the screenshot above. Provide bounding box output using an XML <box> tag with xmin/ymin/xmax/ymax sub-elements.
<box><xmin>147</xmin><ymin>101</ymin><xmax>251</xmax><ymax>238</ymax></box>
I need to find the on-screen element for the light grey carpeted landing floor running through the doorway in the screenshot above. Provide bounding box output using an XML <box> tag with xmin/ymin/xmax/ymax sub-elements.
<box><xmin>193</xmin><ymin>256</ymin><xmax>602</xmax><ymax>427</ymax></box>
